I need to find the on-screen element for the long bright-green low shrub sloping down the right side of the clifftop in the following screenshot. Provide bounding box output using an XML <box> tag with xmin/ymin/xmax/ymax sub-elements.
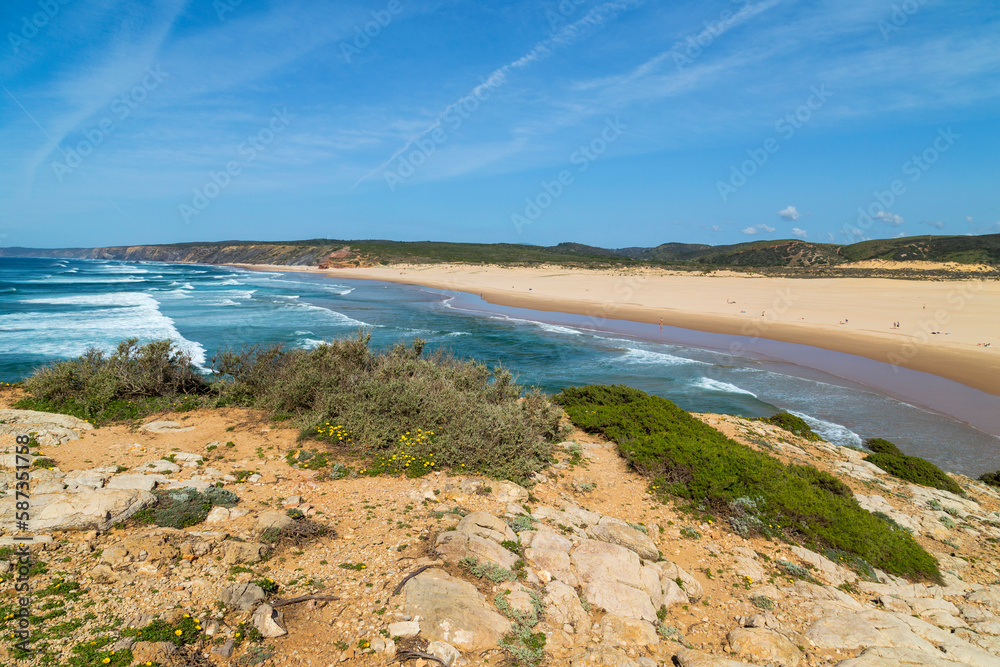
<box><xmin>554</xmin><ymin>385</ymin><xmax>941</xmax><ymax>581</ymax></box>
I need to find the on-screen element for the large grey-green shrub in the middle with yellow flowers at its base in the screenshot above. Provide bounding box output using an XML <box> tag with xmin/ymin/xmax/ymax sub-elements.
<box><xmin>212</xmin><ymin>334</ymin><xmax>562</xmax><ymax>481</ymax></box>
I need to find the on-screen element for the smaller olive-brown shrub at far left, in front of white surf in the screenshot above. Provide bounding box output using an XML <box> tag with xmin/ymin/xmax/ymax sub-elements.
<box><xmin>19</xmin><ymin>338</ymin><xmax>208</xmax><ymax>421</ymax></box>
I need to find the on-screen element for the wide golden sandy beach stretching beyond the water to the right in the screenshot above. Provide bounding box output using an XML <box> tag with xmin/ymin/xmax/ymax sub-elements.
<box><xmin>229</xmin><ymin>264</ymin><xmax>1000</xmax><ymax>395</ymax></box>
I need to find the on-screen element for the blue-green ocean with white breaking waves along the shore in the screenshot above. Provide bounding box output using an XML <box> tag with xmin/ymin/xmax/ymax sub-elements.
<box><xmin>0</xmin><ymin>258</ymin><xmax>1000</xmax><ymax>476</ymax></box>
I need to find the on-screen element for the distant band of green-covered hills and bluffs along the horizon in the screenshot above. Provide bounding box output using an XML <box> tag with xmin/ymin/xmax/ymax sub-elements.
<box><xmin>0</xmin><ymin>234</ymin><xmax>1000</xmax><ymax>268</ymax></box>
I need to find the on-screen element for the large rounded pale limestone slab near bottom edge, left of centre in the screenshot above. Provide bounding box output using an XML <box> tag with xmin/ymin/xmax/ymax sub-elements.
<box><xmin>403</xmin><ymin>568</ymin><xmax>510</xmax><ymax>651</ymax></box>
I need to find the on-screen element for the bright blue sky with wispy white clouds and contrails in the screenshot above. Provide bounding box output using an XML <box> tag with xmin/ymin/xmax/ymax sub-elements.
<box><xmin>0</xmin><ymin>0</ymin><xmax>1000</xmax><ymax>247</ymax></box>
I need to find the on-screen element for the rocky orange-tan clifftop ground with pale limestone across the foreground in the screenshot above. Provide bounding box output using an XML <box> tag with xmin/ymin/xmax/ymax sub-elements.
<box><xmin>0</xmin><ymin>396</ymin><xmax>1000</xmax><ymax>667</ymax></box>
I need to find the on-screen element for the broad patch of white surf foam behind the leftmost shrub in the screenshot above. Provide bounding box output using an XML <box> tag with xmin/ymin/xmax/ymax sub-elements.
<box><xmin>8</xmin><ymin>292</ymin><xmax>208</xmax><ymax>370</ymax></box>
